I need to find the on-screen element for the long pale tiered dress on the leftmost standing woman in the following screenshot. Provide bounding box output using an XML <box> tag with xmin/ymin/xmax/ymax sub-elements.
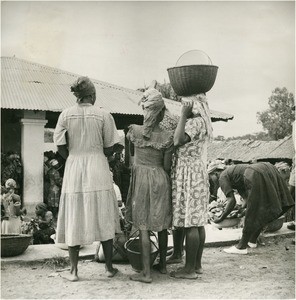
<box><xmin>54</xmin><ymin>103</ymin><xmax>120</xmax><ymax>246</ymax></box>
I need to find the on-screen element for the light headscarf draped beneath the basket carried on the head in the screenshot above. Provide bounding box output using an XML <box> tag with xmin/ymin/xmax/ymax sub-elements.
<box><xmin>182</xmin><ymin>94</ymin><xmax>213</xmax><ymax>141</ymax></box>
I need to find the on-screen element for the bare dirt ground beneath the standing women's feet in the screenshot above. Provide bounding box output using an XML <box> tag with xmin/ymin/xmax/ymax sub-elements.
<box><xmin>1</xmin><ymin>236</ymin><xmax>295</xmax><ymax>299</ymax></box>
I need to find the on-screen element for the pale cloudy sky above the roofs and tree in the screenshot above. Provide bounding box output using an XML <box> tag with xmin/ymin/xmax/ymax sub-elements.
<box><xmin>1</xmin><ymin>1</ymin><xmax>295</xmax><ymax>137</ymax></box>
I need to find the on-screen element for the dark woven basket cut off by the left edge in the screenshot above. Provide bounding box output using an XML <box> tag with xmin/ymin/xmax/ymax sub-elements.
<box><xmin>1</xmin><ymin>234</ymin><xmax>32</xmax><ymax>257</ymax></box>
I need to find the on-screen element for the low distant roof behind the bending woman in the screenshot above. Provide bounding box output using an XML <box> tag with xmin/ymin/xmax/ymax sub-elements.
<box><xmin>208</xmin><ymin>136</ymin><xmax>295</xmax><ymax>162</ymax></box>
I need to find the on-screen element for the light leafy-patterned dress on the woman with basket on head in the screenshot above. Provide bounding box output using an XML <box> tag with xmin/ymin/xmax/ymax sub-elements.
<box><xmin>171</xmin><ymin>117</ymin><xmax>209</xmax><ymax>227</ymax></box>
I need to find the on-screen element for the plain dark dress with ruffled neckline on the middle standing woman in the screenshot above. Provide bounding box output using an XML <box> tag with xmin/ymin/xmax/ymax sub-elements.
<box><xmin>126</xmin><ymin>125</ymin><xmax>173</xmax><ymax>231</ymax></box>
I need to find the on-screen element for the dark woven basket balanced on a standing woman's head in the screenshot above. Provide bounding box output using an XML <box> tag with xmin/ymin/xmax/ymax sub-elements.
<box><xmin>167</xmin><ymin>65</ymin><xmax>218</xmax><ymax>96</ymax></box>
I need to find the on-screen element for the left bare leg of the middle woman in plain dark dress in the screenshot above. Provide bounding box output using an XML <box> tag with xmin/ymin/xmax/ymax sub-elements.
<box><xmin>130</xmin><ymin>230</ymin><xmax>152</xmax><ymax>283</ymax></box>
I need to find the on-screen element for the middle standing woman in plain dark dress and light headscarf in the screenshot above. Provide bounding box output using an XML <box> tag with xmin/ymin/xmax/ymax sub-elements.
<box><xmin>126</xmin><ymin>88</ymin><xmax>173</xmax><ymax>283</ymax></box>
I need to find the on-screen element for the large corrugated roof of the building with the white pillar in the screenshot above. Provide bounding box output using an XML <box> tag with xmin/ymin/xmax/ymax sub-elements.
<box><xmin>1</xmin><ymin>57</ymin><xmax>233</xmax><ymax>121</ymax></box>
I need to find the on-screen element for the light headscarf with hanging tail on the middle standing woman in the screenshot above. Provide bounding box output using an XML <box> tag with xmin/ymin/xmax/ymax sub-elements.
<box><xmin>140</xmin><ymin>88</ymin><xmax>165</xmax><ymax>140</ymax></box>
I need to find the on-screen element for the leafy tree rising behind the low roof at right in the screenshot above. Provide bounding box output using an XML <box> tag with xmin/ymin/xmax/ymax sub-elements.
<box><xmin>257</xmin><ymin>88</ymin><xmax>295</xmax><ymax>140</ymax></box>
